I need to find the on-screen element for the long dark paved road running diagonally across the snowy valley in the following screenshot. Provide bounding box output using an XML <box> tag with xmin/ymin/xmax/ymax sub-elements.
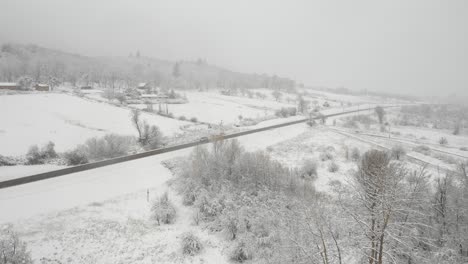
<box><xmin>0</xmin><ymin>106</ymin><xmax>397</xmax><ymax>189</ymax></box>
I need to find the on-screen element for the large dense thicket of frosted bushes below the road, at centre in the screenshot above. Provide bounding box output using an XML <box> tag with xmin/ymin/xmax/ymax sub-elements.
<box><xmin>178</xmin><ymin>140</ymin><xmax>317</xmax><ymax>262</ymax></box>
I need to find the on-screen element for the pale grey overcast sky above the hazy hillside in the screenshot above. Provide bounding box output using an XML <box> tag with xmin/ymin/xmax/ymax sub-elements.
<box><xmin>0</xmin><ymin>0</ymin><xmax>468</xmax><ymax>95</ymax></box>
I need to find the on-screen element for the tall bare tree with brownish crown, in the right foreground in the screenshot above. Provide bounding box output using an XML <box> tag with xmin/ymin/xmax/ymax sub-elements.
<box><xmin>348</xmin><ymin>150</ymin><xmax>429</xmax><ymax>264</ymax></box>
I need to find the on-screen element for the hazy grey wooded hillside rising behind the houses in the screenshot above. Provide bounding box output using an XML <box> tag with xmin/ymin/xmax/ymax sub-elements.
<box><xmin>0</xmin><ymin>44</ymin><xmax>295</xmax><ymax>90</ymax></box>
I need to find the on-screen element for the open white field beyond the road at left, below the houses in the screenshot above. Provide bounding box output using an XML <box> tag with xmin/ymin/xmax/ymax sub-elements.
<box><xmin>0</xmin><ymin>93</ymin><xmax>191</xmax><ymax>155</ymax></box>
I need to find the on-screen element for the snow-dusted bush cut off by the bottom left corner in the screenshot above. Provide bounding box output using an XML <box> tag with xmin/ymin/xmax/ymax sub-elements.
<box><xmin>0</xmin><ymin>226</ymin><xmax>33</xmax><ymax>264</ymax></box>
